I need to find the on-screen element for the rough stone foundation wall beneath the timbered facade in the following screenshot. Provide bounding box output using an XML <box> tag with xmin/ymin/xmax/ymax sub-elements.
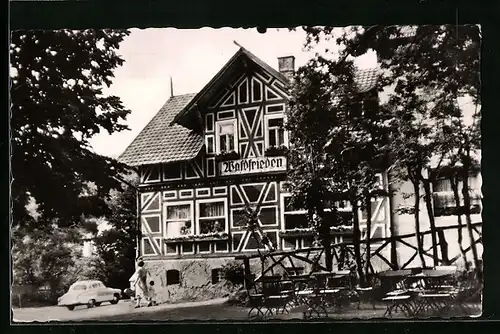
<box><xmin>144</xmin><ymin>257</ymin><xmax>240</xmax><ymax>303</ymax></box>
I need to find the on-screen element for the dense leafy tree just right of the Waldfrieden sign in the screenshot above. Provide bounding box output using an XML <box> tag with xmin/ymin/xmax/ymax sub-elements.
<box><xmin>286</xmin><ymin>57</ymin><xmax>387</xmax><ymax>284</ymax></box>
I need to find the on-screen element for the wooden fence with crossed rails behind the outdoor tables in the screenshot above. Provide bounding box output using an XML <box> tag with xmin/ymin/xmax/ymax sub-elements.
<box><xmin>236</xmin><ymin>223</ymin><xmax>482</xmax><ymax>286</ymax></box>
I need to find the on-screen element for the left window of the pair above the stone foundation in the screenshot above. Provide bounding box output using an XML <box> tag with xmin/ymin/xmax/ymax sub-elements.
<box><xmin>165</xmin><ymin>202</ymin><xmax>193</xmax><ymax>238</ymax></box>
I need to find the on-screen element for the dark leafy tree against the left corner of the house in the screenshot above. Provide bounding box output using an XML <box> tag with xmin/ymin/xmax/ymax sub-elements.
<box><xmin>95</xmin><ymin>174</ymin><xmax>140</xmax><ymax>289</ymax></box>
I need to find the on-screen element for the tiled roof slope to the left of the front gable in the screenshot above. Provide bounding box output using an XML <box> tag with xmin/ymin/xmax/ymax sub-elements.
<box><xmin>118</xmin><ymin>94</ymin><xmax>204</xmax><ymax>166</ymax></box>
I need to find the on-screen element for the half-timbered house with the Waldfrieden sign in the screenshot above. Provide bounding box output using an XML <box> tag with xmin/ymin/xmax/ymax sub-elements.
<box><xmin>120</xmin><ymin>48</ymin><xmax>480</xmax><ymax>301</ymax></box>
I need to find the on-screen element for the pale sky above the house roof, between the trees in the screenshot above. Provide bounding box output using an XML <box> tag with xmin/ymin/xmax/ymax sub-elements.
<box><xmin>91</xmin><ymin>28</ymin><xmax>377</xmax><ymax>158</ymax></box>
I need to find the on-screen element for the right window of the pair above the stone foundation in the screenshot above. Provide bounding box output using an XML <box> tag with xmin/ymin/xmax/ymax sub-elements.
<box><xmin>198</xmin><ymin>200</ymin><xmax>226</xmax><ymax>234</ymax></box>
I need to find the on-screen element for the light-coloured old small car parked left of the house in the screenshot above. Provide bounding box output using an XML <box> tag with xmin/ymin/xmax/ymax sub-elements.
<box><xmin>57</xmin><ymin>280</ymin><xmax>121</xmax><ymax>311</ymax></box>
